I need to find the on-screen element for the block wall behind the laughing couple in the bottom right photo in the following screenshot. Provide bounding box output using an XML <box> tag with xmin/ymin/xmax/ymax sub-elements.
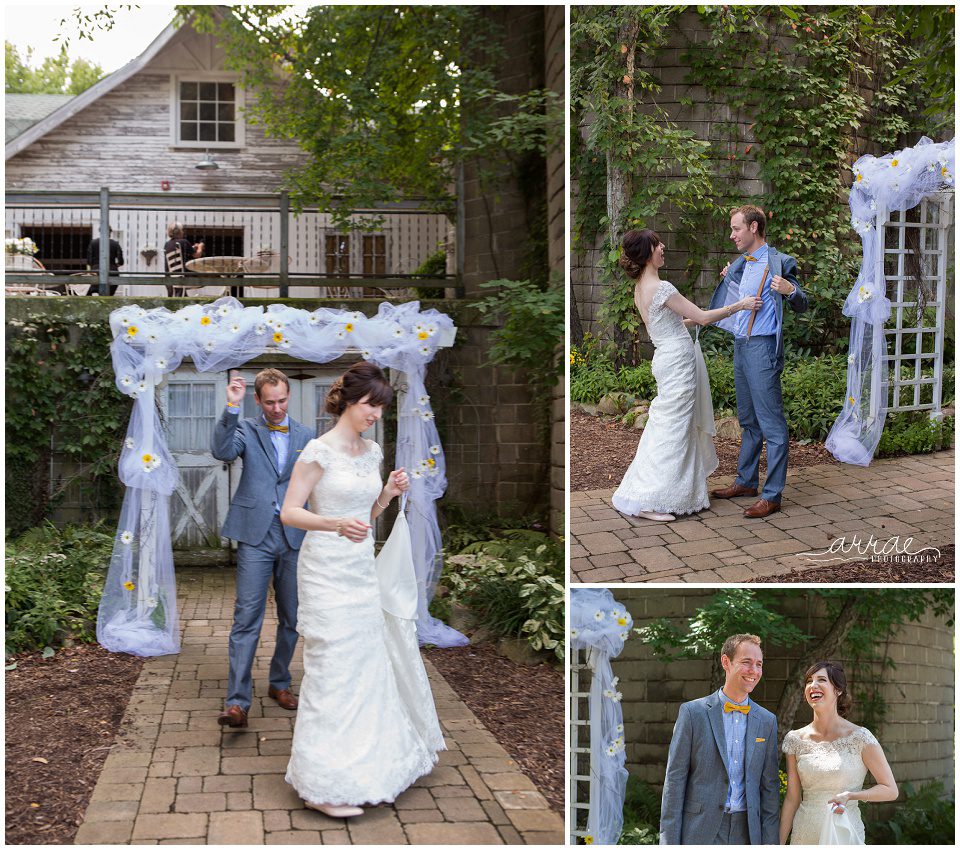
<box><xmin>613</xmin><ymin>588</ymin><xmax>954</xmax><ymax>791</ymax></box>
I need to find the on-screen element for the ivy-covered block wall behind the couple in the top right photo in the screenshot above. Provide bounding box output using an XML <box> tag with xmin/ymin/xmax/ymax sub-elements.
<box><xmin>571</xmin><ymin>5</ymin><xmax>953</xmax><ymax>362</ymax></box>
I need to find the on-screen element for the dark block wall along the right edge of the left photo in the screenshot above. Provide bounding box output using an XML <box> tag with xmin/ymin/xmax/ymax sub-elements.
<box><xmin>458</xmin><ymin>6</ymin><xmax>564</xmax><ymax>532</ymax></box>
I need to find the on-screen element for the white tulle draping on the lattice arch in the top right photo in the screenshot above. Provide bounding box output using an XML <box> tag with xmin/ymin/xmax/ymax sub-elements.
<box><xmin>826</xmin><ymin>136</ymin><xmax>956</xmax><ymax>466</ymax></box>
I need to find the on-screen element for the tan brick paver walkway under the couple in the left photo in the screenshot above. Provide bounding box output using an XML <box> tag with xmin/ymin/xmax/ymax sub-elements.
<box><xmin>75</xmin><ymin>568</ymin><xmax>563</xmax><ymax>844</ymax></box>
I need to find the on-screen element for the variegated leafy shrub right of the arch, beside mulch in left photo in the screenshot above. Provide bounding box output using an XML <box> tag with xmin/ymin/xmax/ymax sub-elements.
<box><xmin>441</xmin><ymin>529</ymin><xmax>564</xmax><ymax>661</ymax></box>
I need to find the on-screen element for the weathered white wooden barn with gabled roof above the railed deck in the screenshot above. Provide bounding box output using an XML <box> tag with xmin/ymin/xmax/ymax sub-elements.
<box><xmin>4</xmin><ymin>10</ymin><xmax>455</xmax><ymax>297</ymax></box>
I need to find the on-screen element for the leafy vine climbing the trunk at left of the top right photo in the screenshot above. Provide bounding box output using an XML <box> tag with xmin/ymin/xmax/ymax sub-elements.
<box><xmin>570</xmin><ymin>6</ymin><xmax>713</xmax><ymax>363</ymax></box>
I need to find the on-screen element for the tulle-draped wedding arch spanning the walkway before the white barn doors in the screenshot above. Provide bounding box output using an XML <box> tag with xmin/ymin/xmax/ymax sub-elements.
<box><xmin>97</xmin><ymin>297</ymin><xmax>467</xmax><ymax>656</ymax></box>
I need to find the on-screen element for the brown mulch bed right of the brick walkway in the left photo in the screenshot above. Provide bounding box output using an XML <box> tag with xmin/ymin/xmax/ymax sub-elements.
<box><xmin>423</xmin><ymin>643</ymin><xmax>564</xmax><ymax>812</ymax></box>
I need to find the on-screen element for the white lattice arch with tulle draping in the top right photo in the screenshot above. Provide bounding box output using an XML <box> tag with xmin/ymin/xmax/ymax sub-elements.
<box><xmin>826</xmin><ymin>136</ymin><xmax>956</xmax><ymax>466</ymax></box>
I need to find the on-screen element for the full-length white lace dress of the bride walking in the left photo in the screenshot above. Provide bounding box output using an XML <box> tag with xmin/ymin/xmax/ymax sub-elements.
<box><xmin>286</xmin><ymin>440</ymin><xmax>446</xmax><ymax>806</ymax></box>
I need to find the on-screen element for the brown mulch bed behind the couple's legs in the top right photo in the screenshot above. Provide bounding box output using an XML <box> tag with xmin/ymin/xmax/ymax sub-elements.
<box><xmin>570</xmin><ymin>410</ymin><xmax>839</xmax><ymax>491</ymax></box>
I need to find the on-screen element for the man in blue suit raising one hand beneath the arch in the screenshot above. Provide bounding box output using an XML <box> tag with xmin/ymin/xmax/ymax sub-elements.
<box><xmin>211</xmin><ymin>369</ymin><xmax>313</xmax><ymax>727</ymax></box>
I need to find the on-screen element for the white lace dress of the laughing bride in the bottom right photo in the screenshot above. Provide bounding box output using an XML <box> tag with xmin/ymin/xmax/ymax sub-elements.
<box><xmin>783</xmin><ymin>726</ymin><xmax>877</xmax><ymax>844</ymax></box>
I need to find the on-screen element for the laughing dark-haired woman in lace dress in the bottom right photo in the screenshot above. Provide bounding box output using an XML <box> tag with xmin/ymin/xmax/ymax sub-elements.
<box><xmin>780</xmin><ymin>661</ymin><xmax>898</xmax><ymax>844</ymax></box>
